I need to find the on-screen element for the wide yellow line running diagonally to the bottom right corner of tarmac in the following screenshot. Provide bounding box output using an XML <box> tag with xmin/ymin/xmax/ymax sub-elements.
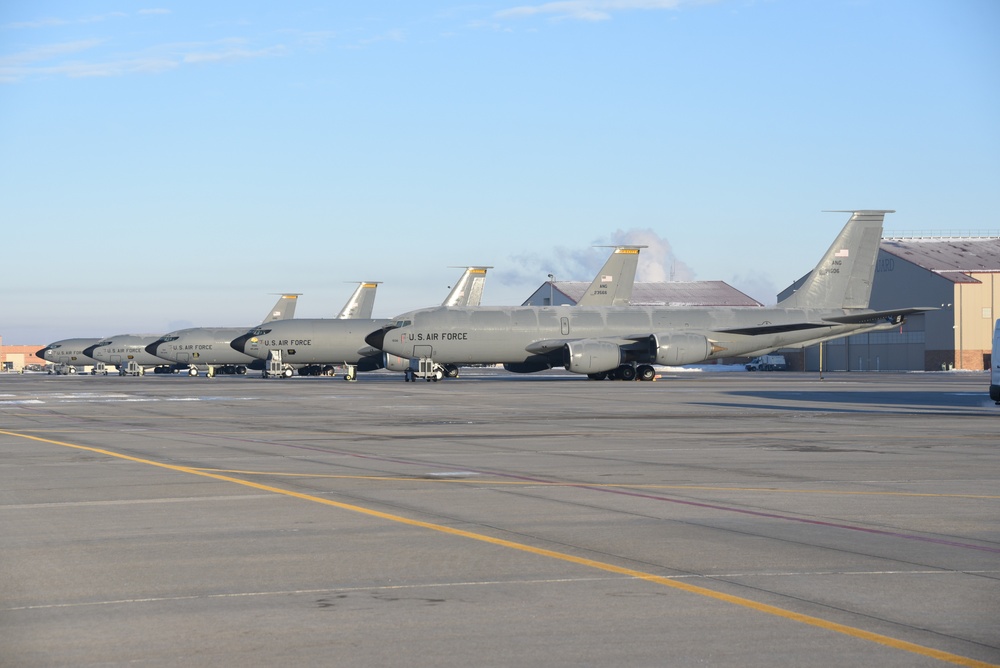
<box><xmin>0</xmin><ymin>430</ymin><xmax>1000</xmax><ymax>668</ymax></box>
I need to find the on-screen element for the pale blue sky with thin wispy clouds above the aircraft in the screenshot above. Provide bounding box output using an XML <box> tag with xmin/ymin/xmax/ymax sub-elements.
<box><xmin>0</xmin><ymin>0</ymin><xmax>1000</xmax><ymax>344</ymax></box>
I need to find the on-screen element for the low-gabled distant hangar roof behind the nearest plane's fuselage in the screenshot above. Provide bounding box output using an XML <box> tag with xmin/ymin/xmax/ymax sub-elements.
<box><xmin>522</xmin><ymin>281</ymin><xmax>762</xmax><ymax>307</ymax></box>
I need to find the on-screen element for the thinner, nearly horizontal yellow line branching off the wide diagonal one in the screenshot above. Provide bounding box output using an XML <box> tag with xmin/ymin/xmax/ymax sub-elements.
<box><xmin>196</xmin><ymin>468</ymin><xmax>1000</xmax><ymax>499</ymax></box>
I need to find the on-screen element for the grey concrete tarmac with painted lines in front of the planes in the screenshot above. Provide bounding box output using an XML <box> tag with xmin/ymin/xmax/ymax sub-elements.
<box><xmin>0</xmin><ymin>370</ymin><xmax>1000</xmax><ymax>668</ymax></box>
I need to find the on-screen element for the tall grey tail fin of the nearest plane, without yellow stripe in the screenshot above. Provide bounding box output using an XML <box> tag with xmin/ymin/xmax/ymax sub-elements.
<box><xmin>778</xmin><ymin>209</ymin><xmax>895</xmax><ymax>309</ymax></box>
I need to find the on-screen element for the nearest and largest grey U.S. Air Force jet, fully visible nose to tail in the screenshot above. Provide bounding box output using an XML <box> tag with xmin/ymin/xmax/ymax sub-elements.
<box><xmin>365</xmin><ymin>210</ymin><xmax>929</xmax><ymax>380</ymax></box>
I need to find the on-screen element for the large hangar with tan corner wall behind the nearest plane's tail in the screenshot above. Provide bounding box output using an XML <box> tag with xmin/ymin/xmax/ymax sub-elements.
<box><xmin>778</xmin><ymin>234</ymin><xmax>1000</xmax><ymax>371</ymax></box>
